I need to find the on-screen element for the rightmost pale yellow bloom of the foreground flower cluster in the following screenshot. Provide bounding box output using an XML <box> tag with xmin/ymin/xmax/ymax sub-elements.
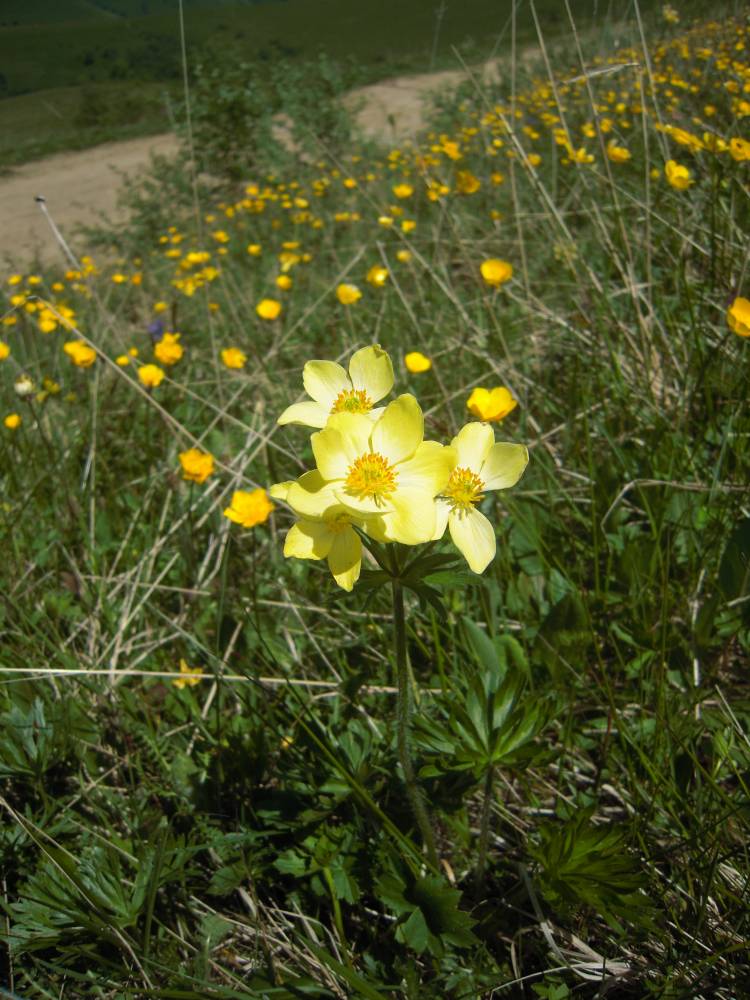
<box><xmin>434</xmin><ymin>424</ymin><xmax>529</xmax><ymax>573</ymax></box>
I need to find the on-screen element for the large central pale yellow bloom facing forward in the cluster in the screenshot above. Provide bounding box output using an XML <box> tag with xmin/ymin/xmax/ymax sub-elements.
<box><xmin>302</xmin><ymin>394</ymin><xmax>455</xmax><ymax>545</ymax></box>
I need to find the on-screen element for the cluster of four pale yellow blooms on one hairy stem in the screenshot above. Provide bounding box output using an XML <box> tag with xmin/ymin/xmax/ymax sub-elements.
<box><xmin>270</xmin><ymin>344</ymin><xmax>528</xmax><ymax>590</ymax></box>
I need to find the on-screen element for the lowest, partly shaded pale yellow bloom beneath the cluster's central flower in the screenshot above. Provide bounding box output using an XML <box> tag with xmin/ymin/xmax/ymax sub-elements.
<box><xmin>271</xmin><ymin>473</ymin><xmax>364</xmax><ymax>591</ymax></box>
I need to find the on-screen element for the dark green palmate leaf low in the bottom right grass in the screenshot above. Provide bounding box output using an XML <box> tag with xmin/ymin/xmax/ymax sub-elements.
<box><xmin>529</xmin><ymin>809</ymin><xmax>652</xmax><ymax>932</ymax></box>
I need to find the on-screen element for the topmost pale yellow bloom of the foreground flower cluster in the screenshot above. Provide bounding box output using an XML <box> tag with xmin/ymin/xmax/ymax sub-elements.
<box><xmin>277</xmin><ymin>344</ymin><xmax>393</xmax><ymax>427</ymax></box>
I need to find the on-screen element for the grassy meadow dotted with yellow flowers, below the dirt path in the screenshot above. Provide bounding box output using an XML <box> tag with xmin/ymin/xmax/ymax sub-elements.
<box><xmin>0</xmin><ymin>5</ymin><xmax>750</xmax><ymax>1000</ymax></box>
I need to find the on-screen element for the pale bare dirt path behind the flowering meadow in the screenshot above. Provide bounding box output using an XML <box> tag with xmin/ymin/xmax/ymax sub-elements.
<box><xmin>0</xmin><ymin>64</ymin><xmax>506</xmax><ymax>270</ymax></box>
